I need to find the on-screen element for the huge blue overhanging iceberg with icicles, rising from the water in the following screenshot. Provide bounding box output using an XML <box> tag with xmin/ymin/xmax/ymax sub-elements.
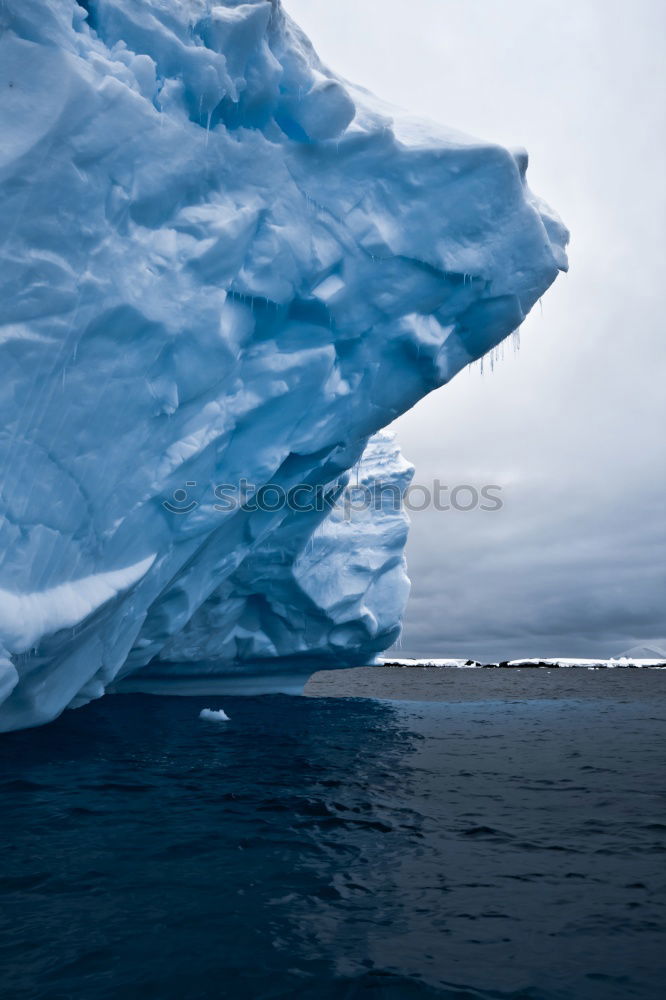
<box><xmin>0</xmin><ymin>0</ymin><xmax>567</xmax><ymax>730</ymax></box>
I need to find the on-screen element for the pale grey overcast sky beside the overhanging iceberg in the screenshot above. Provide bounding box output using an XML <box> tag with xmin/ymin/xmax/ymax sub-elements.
<box><xmin>285</xmin><ymin>0</ymin><xmax>666</xmax><ymax>659</ymax></box>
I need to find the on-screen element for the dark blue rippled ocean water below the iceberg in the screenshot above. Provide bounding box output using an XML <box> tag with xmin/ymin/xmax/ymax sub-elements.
<box><xmin>0</xmin><ymin>671</ymin><xmax>666</xmax><ymax>1000</ymax></box>
